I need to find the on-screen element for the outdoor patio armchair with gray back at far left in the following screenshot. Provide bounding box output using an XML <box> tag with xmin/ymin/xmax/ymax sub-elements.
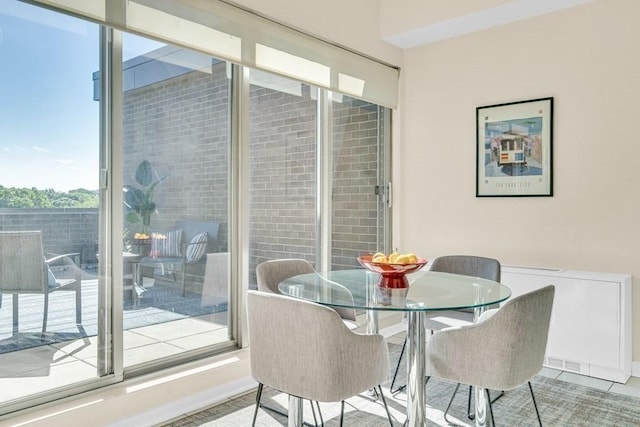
<box><xmin>0</xmin><ymin>231</ymin><xmax>82</xmax><ymax>337</ymax></box>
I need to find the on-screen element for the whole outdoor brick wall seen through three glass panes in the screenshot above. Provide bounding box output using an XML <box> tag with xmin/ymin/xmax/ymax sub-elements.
<box><xmin>124</xmin><ymin>63</ymin><xmax>379</xmax><ymax>283</ymax></box>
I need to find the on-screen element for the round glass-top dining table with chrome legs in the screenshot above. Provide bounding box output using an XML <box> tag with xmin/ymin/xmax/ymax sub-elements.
<box><xmin>278</xmin><ymin>269</ymin><xmax>511</xmax><ymax>426</ymax></box>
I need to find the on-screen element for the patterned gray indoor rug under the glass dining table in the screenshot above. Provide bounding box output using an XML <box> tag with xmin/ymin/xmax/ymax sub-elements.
<box><xmin>162</xmin><ymin>341</ymin><xmax>640</xmax><ymax>427</ymax></box>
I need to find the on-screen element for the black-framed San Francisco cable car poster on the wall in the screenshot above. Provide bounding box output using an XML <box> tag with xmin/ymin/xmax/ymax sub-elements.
<box><xmin>476</xmin><ymin>98</ymin><xmax>553</xmax><ymax>197</ymax></box>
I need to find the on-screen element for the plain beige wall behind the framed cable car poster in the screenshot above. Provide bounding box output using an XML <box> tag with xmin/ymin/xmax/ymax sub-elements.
<box><xmin>394</xmin><ymin>0</ymin><xmax>640</xmax><ymax>362</ymax></box>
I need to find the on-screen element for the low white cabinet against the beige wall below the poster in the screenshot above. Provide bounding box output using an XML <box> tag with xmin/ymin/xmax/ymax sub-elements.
<box><xmin>501</xmin><ymin>266</ymin><xmax>632</xmax><ymax>383</ymax></box>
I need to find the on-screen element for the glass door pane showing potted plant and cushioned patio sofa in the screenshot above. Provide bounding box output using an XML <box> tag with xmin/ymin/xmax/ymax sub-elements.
<box><xmin>122</xmin><ymin>34</ymin><xmax>232</xmax><ymax>368</ymax></box>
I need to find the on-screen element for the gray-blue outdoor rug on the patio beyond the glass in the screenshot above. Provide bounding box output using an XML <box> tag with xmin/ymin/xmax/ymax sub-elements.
<box><xmin>0</xmin><ymin>280</ymin><xmax>227</xmax><ymax>354</ymax></box>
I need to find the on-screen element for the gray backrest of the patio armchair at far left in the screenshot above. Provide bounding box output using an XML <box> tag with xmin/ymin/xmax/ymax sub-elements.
<box><xmin>0</xmin><ymin>231</ymin><xmax>48</xmax><ymax>293</ymax></box>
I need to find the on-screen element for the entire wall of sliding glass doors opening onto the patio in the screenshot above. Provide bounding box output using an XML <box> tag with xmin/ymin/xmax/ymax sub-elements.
<box><xmin>0</xmin><ymin>0</ymin><xmax>390</xmax><ymax>416</ymax></box>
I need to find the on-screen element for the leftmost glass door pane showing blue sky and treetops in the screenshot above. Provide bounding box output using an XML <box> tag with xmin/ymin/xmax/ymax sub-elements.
<box><xmin>0</xmin><ymin>1</ymin><xmax>106</xmax><ymax>408</ymax></box>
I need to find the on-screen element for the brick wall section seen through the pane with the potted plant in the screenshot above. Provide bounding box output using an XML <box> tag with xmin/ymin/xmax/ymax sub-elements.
<box><xmin>123</xmin><ymin>63</ymin><xmax>229</xmax><ymax>251</ymax></box>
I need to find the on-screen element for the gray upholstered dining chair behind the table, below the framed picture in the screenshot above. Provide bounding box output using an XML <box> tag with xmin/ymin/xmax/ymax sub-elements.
<box><xmin>390</xmin><ymin>255</ymin><xmax>501</xmax><ymax>406</ymax></box>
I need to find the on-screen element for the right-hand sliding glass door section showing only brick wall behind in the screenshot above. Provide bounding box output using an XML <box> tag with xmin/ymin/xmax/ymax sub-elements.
<box><xmin>249</xmin><ymin>70</ymin><xmax>390</xmax><ymax>280</ymax></box>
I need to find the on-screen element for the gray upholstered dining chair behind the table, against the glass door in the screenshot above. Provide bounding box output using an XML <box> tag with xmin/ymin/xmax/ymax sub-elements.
<box><xmin>256</xmin><ymin>258</ymin><xmax>359</xmax><ymax>329</ymax></box>
